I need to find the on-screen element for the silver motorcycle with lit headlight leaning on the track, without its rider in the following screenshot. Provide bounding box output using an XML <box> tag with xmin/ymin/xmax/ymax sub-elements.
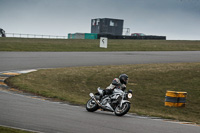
<box><xmin>86</xmin><ymin>87</ymin><xmax>132</xmax><ymax>116</ymax></box>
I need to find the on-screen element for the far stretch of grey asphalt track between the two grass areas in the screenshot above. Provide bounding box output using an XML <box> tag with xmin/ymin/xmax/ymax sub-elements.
<box><xmin>0</xmin><ymin>51</ymin><xmax>200</xmax><ymax>72</ymax></box>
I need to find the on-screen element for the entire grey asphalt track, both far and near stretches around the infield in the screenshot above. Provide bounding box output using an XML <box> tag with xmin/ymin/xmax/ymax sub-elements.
<box><xmin>0</xmin><ymin>51</ymin><xmax>200</xmax><ymax>133</ymax></box>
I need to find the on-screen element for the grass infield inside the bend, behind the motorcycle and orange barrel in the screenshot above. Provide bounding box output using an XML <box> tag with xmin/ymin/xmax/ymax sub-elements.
<box><xmin>6</xmin><ymin>63</ymin><xmax>200</xmax><ymax>123</ymax></box>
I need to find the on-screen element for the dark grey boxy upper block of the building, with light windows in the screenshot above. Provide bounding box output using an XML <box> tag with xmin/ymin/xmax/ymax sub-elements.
<box><xmin>91</xmin><ymin>18</ymin><xmax>124</xmax><ymax>35</ymax></box>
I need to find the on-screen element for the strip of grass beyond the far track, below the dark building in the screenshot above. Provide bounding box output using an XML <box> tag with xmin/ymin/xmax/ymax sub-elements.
<box><xmin>0</xmin><ymin>38</ymin><xmax>200</xmax><ymax>51</ymax></box>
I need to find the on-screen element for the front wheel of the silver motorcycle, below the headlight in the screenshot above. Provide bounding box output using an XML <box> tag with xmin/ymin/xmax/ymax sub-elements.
<box><xmin>115</xmin><ymin>103</ymin><xmax>131</xmax><ymax>116</ymax></box>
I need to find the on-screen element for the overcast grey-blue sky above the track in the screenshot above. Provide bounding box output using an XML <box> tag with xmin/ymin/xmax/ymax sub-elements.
<box><xmin>0</xmin><ymin>0</ymin><xmax>200</xmax><ymax>40</ymax></box>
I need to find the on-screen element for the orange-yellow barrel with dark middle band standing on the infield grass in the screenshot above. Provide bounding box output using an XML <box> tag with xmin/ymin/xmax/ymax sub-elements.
<box><xmin>165</xmin><ymin>91</ymin><xmax>187</xmax><ymax>107</ymax></box>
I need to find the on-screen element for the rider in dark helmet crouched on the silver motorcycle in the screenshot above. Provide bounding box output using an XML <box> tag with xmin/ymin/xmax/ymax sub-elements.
<box><xmin>103</xmin><ymin>74</ymin><xmax>128</xmax><ymax>96</ymax></box>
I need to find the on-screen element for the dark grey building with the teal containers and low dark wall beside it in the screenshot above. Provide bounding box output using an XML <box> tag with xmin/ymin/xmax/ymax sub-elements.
<box><xmin>68</xmin><ymin>18</ymin><xmax>166</xmax><ymax>40</ymax></box>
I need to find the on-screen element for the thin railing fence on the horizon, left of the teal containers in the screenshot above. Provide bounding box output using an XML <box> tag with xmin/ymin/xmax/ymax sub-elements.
<box><xmin>6</xmin><ymin>33</ymin><xmax>68</xmax><ymax>39</ymax></box>
